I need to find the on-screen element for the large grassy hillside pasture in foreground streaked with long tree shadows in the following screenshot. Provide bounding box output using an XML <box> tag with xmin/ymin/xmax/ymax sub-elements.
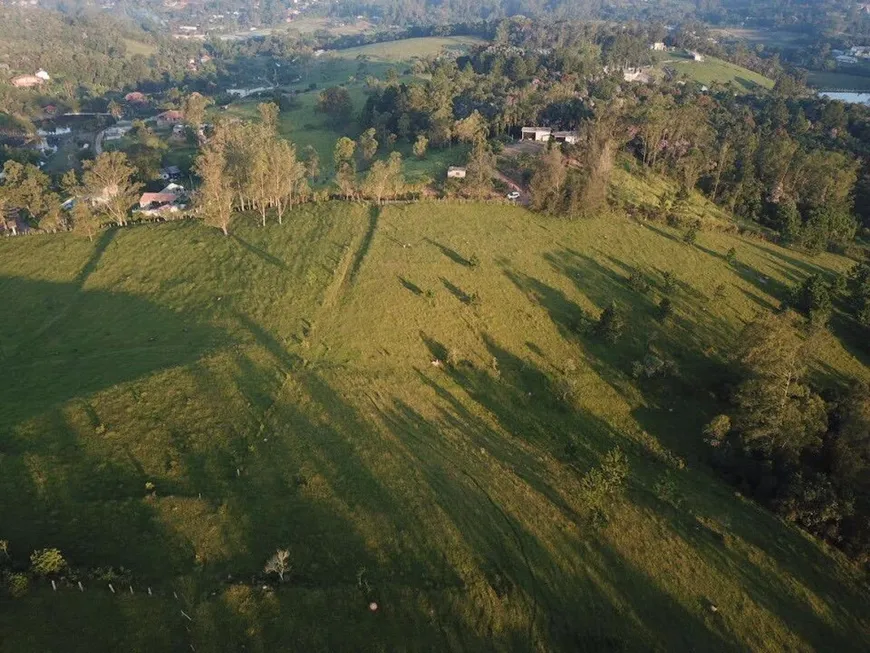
<box><xmin>0</xmin><ymin>196</ymin><xmax>870</xmax><ymax>653</ymax></box>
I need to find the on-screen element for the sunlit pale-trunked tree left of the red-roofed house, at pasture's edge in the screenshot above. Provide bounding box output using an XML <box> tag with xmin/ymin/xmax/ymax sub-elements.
<box><xmin>82</xmin><ymin>152</ymin><xmax>142</xmax><ymax>226</ymax></box>
